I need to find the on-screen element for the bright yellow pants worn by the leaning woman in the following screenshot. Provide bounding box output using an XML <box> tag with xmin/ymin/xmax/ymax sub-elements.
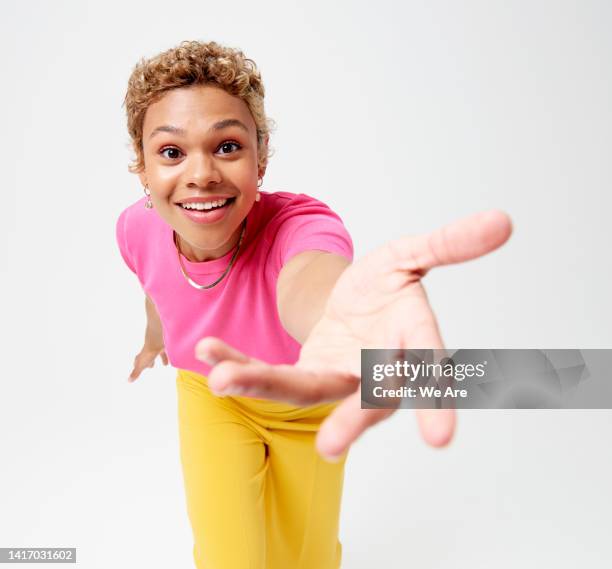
<box><xmin>176</xmin><ymin>370</ymin><xmax>346</xmax><ymax>569</ymax></box>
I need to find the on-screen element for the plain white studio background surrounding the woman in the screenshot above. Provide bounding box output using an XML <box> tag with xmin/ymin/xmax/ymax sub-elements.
<box><xmin>0</xmin><ymin>0</ymin><xmax>612</xmax><ymax>569</ymax></box>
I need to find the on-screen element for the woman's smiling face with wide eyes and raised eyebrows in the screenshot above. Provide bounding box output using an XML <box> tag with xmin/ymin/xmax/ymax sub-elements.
<box><xmin>139</xmin><ymin>85</ymin><xmax>263</xmax><ymax>261</ymax></box>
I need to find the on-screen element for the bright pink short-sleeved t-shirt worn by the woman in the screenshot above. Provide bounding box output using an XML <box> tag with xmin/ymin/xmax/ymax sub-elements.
<box><xmin>116</xmin><ymin>191</ymin><xmax>353</xmax><ymax>375</ymax></box>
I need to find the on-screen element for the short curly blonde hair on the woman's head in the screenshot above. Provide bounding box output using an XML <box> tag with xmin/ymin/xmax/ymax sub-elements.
<box><xmin>124</xmin><ymin>41</ymin><xmax>274</xmax><ymax>173</ymax></box>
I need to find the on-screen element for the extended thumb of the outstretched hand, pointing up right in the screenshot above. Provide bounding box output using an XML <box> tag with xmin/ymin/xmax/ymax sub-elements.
<box><xmin>387</xmin><ymin>210</ymin><xmax>512</xmax><ymax>274</ymax></box>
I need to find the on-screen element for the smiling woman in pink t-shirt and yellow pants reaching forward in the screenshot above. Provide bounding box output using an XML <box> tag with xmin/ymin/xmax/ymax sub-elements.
<box><xmin>117</xmin><ymin>42</ymin><xmax>509</xmax><ymax>569</ymax></box>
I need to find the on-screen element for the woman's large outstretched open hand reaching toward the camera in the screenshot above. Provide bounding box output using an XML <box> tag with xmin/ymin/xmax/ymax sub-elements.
<box><xmin>196</xmin><ymin>210</ymin><xmax>512</xmax><ymax>459</ymax></box>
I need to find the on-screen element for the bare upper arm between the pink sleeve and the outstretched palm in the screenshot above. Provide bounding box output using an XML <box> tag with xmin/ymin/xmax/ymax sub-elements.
<box><xmin>276</xmin><ymin>251</ymin><xmax>351</xmax><ymax>344</ymax></box>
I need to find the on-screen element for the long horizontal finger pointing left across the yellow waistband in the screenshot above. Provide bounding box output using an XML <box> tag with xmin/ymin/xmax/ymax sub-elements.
<box><xmin>208</xmin><ymin>361</ymin><xmax>359</xmax><ymax>406</ymax></box>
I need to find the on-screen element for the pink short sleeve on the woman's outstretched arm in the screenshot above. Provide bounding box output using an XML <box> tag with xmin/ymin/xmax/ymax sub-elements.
<box><xmin>276</xmin><ymin>200</ymin><xmax>353</xmax><ymax>267</ymax></box>
